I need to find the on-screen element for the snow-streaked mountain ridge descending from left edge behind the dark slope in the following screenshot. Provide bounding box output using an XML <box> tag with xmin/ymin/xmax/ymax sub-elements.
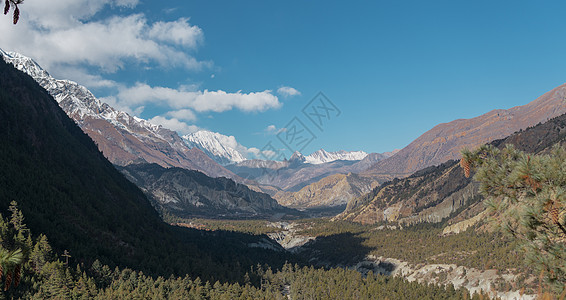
<box><xmin>0</xmin><ymin>49</ymin><xmax>237</xmax><ymax>179</ymax></box>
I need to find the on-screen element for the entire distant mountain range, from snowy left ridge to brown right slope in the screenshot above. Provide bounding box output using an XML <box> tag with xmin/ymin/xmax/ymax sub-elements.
<box><xmin>5</xmin><ymin>50</ymin><xmax>566</xmax><ymax>220</ymax></box>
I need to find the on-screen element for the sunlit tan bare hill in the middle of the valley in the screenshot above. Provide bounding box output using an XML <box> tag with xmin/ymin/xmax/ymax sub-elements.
<box><xmin>273</xmin><ymin>173</ymin><xmax>378</xmax><ymax>209</ymax></box>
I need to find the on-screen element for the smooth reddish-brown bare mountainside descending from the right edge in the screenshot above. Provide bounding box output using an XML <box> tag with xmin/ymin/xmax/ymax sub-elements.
<box><xmin>365</xmin><ymin>85</ymin><xmax>566</xmax><ymax>177</ymax></box>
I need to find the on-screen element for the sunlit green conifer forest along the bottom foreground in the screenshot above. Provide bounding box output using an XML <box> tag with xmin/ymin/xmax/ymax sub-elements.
<box><xmin>0</xmin><ymin>202</ymin><xmax>492</xmax><ymax>299</ymax></box>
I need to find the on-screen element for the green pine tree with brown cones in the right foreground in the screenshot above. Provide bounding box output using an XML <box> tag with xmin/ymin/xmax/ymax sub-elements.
<box><xmin>462</xmin><ymin>145</ymin><xmax>566</xmax><ymax>292</ymax></box>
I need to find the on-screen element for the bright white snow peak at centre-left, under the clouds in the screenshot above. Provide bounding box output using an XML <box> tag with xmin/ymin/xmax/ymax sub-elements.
<box><xmin>183</xmin><ymin>130</ymin><xmax>246</xmax><ymax>165</ymax></box>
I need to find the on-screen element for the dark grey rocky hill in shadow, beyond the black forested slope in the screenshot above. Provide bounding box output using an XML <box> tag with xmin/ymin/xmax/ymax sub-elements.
<box><xmin>118</xmin><ymin>164</ymin><xmax>298</xmax><ymax>218</ymax></box>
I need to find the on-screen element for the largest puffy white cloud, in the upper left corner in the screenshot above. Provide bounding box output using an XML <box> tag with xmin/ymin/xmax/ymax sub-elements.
<box><xmin>0</xmin><ymin>0</ymin><xmax>207</xmax><ymax>81</ymax></box>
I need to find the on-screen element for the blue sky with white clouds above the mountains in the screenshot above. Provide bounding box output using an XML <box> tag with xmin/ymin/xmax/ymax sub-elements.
<box><xmin>0</xmin><ymin>0</ymin><xmax>566</xmax><ymax>154</ymax></box>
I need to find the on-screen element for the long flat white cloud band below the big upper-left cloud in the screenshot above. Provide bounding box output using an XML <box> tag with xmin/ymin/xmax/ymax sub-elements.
<box><xmin>117</xmin><ymin>83</ymin><xmax>281</xmax><ymax>112</ymax></box>
